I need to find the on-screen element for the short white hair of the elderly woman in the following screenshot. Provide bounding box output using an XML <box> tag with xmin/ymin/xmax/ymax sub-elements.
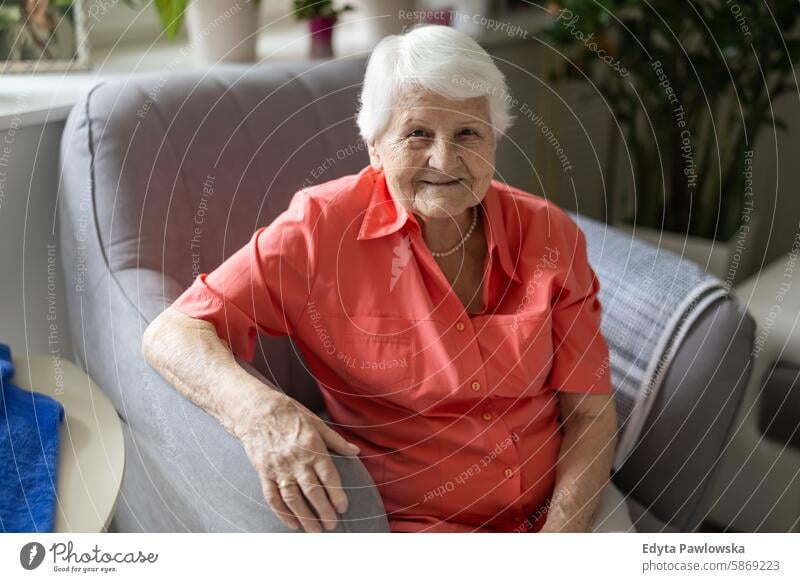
<box><xmin>356</xmin><ymin>24</ymin><xmax>514</xmax><ymax>141</ymax></box>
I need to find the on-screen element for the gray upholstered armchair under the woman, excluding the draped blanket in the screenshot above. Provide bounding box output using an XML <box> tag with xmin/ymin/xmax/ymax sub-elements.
<box><xmin>59</xmin><ymin>59</ymin><xmax>753</xmax><ymax>531</ymax></box>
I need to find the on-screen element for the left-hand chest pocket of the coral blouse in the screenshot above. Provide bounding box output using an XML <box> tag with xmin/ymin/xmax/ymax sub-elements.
<box><xmin>339</xmin><ymin>316</ymin><xmax>414</xmax><ymax>405</ymax></box>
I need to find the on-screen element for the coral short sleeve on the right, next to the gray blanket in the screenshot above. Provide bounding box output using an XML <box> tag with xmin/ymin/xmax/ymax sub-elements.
<box><xmin>550</xmin><ymin>212</ymin><xmax>612</xmax><ymax>394</ymax></box>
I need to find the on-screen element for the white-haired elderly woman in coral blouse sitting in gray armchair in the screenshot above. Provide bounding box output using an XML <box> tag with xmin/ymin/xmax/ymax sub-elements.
<box><xmin>143</xmin><ymin>26</ymin><xmax>624</xmax><ymax>532</ymax></box>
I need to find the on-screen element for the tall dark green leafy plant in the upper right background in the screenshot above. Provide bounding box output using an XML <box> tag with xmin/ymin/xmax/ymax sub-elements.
<box><xmin>543</xmin><ymin>0</ymin><xmax>800</xmax><ymax>278</ymax></box>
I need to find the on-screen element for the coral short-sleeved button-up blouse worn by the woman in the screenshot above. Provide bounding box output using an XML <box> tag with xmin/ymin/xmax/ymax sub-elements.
<box><xmin>173</xmin><ymin>166</ymin><xmax>611</xmax><ymax>532</ymax></box>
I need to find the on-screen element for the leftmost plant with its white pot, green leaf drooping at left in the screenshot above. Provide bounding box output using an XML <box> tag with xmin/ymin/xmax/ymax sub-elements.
<box><xmin>125</xmin><ymin>0</ymin><xmax>260</xmax><ymax>64</ymax></box>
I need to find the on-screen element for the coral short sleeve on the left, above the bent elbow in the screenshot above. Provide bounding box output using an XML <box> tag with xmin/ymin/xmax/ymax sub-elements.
<box><xmin>172</xmin><ymin>190</ymin><xmax>319</xmax><ymax>362</ymax></box>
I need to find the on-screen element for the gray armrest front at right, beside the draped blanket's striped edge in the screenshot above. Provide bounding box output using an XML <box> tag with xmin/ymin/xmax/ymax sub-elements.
<box><xmin>614</xmin><ymin>299</ymin><xmax>755</xmax><ymax>531</ymax></box>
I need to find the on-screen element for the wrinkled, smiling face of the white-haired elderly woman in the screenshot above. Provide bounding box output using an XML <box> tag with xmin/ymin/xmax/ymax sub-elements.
<box><xmin>368</xmin><ymin>89</ymin><xmax>496</xmax><ymax>218</ymax></box>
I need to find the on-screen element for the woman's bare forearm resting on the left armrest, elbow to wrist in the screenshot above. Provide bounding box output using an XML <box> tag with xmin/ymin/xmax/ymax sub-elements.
<box><xmin>142</xmin><ymin>307</ymin><xmax>285</xmax><ymax>437</ymax></box>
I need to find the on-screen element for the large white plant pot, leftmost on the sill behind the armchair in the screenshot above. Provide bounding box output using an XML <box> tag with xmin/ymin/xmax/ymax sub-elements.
<box><xmin>186</xmin><ymin>0</ymin><xmax>258</xmax><ymax>64</ymax></box>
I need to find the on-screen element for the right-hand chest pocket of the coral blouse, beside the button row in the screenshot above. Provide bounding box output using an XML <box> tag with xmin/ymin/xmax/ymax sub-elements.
<box><xmin>475</xmin><ymin>312</ymin><xmax>553</xmax><ymax>398</ymax></box>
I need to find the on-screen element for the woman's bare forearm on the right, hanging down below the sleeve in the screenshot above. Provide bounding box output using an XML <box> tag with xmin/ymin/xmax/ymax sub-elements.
<box><xmin>540</xmin><ymin>394</ymin><xmax>617</xmax><ymax>532</ymax></box>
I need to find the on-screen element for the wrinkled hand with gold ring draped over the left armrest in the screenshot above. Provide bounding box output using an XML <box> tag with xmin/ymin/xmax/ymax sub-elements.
<box><xmin>236</xmin><ymin>391</ymin><xmax>359</xmax><ymax>532</ymax></box>
